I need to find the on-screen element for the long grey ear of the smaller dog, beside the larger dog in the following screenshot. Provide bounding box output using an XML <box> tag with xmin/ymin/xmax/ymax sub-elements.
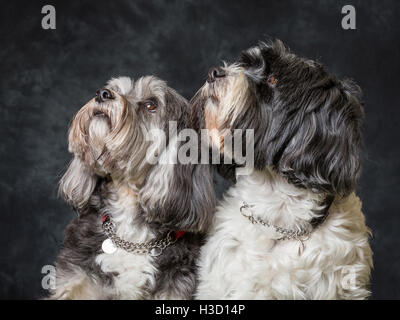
<box><xmin>139</xmin><ymin>91</ymin><xmax>215</xmax><ymax>232</ymax></box>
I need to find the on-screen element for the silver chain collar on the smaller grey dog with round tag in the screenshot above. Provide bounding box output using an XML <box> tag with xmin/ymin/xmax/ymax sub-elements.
<box><xmin>103</xmin><ymin>215</ymin><xmax>177</xmax><ymax>256</ymax></box>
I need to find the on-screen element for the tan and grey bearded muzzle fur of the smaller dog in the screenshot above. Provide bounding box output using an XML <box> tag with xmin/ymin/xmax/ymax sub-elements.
<box><xmin>69</xmin><ymin>95</ymin><xmax>147</xmax><ymax>180</ymax></box>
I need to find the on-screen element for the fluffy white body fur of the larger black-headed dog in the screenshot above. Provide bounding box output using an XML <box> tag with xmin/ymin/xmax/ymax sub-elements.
<box><xmin>197</xmin><ymin>170</ymin><xmax>372</xmax><ymax>299</ymax></box>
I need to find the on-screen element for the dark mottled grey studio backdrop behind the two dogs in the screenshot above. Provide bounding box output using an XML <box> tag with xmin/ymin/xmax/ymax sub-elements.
<box><xmin>0</xmin><ymin>0</ymin><xmax>400</xmax><ymax>299</ymax></box>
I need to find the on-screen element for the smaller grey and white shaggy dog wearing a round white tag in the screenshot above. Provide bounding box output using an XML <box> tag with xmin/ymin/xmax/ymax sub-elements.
<box><xmin>50</xmin><ymin>76</ymin><xmax>214</xmax><ymax>299</ymax></box>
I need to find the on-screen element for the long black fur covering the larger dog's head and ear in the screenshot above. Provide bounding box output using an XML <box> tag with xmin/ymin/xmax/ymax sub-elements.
<box><xmin>233</xmin><ymin>40</ymin><xmax>363</xmax><ymax>195</ymax></box>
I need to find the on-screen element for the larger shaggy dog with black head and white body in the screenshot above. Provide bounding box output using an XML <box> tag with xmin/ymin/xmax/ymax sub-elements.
<box><xmin>192</xmin><ymin>40</ymin><xmax>372</xmax><ymax>299</ymax></box>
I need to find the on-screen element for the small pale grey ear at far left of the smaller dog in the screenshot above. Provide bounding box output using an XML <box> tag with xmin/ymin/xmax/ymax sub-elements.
<box><xmin>58</xmin><ymin>157</ymin><xmax>97</xmax><ymax>210</ymax></box>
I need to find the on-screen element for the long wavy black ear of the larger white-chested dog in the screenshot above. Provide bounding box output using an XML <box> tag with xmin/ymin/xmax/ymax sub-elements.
<box><xmin>266</xmin><ymin>80</ymin><xmax>364</xmax><ymax>195</ymax></box>
